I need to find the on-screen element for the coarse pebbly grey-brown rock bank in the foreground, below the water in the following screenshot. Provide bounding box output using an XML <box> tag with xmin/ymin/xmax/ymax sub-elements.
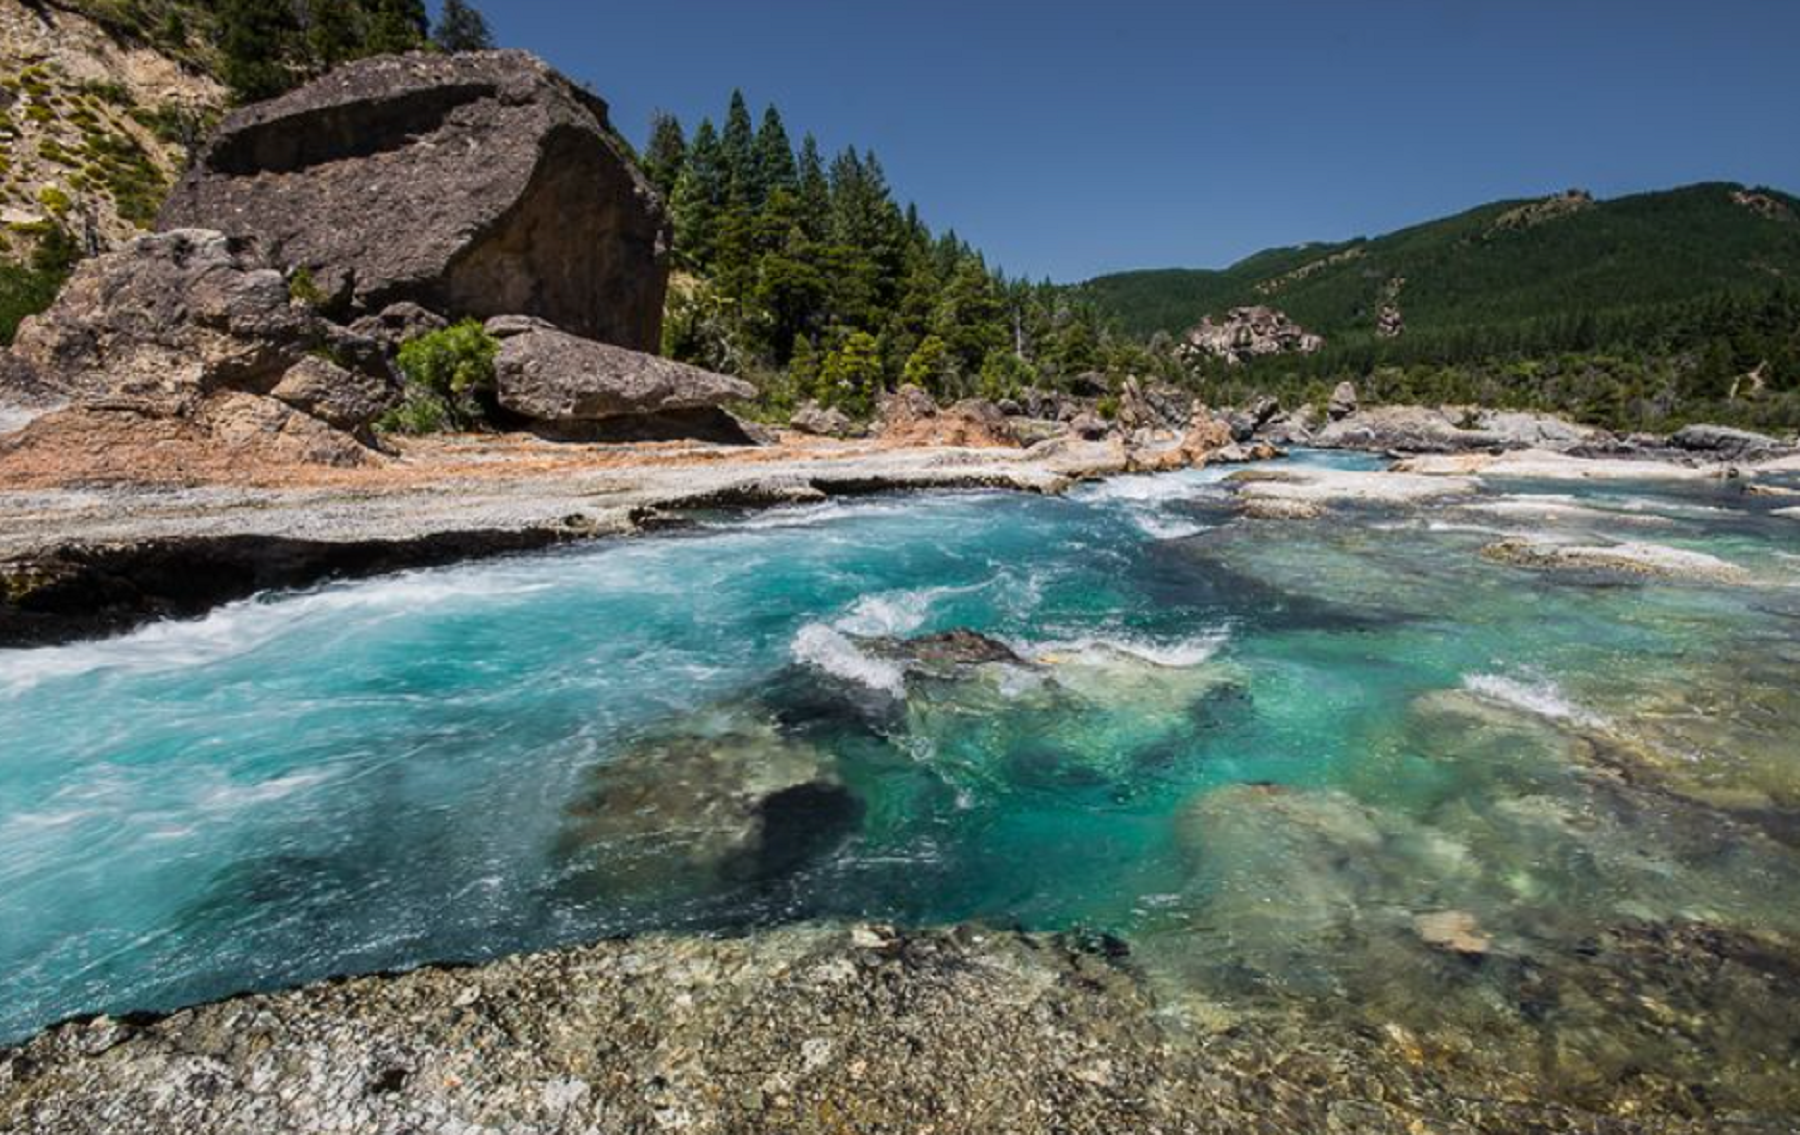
<box><xmin>0</xmin><ymin>926</ymin><xmax>1784</xmax><ymax>1135</ymax></box>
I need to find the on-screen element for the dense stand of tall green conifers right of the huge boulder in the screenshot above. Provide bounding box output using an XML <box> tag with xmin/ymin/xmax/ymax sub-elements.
<box><xmin>643</xmin><ymin>92</ymin><xmax>1130</xmax><ymax>416</ymax></box>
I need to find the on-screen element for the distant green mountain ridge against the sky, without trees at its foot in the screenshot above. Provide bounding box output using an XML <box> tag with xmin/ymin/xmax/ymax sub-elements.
<box><xmin>1071</xmin><ymin>182</ymin><xmax>1800</xmax><ymax>347</ymax></box>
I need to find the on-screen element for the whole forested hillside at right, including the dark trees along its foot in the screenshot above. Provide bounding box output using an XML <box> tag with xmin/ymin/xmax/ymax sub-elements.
<box><xmin>1073</xmin><ymin>183</ymin><xmax>1800</xmax><ymax>428</ymax></box>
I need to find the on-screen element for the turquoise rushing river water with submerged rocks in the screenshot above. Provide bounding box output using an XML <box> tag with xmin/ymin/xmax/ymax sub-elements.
<box><xmin>0</xmin><ymin>447</ymin><xmax>1800</xmax><ymax>1108</ymax></box>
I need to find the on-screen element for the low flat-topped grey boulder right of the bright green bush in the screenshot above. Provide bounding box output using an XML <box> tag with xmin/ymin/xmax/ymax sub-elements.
<box><xmin>488</xmin><ymin>317</ymin><xmax>756</xmax><ymax>442</ymax></box>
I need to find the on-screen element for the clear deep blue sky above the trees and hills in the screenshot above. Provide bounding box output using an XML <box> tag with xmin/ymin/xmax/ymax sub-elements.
<box><xmin>457</xmin><ymin>0</ymin><xmax>1800</xmax><ymax>281</ymax></box>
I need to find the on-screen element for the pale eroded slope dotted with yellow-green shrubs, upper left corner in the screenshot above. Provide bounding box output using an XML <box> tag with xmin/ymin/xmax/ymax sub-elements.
<box><xmin>0</xmin><ymin>0</ymin><xmax>225</xmax><ymax>259</ymax></box>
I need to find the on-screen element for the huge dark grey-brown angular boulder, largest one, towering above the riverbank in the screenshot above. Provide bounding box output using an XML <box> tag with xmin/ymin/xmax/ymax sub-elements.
<box><xmin>158</xmin><ymin>50</ymin><xmax>668</xmax><ymax>351</ymax></box>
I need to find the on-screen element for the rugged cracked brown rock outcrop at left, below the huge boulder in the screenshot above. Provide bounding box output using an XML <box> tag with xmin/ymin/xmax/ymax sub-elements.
<box><xmin>0</xmin><ymin>230</ymin><xmax>398</xmax><ymax>464</ymax></box>
